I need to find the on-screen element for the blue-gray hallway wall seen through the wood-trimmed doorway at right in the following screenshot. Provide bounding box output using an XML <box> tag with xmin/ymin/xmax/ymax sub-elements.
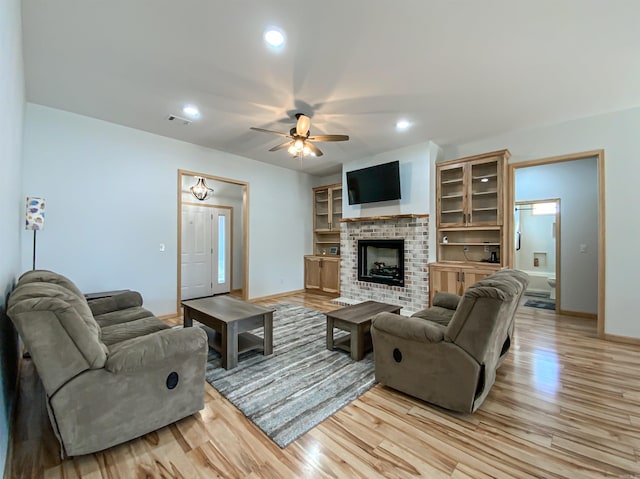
<box><xmin>515</xmin><ymin>158</ymin><xmax>598</xmax><ymax>314</ymax></box>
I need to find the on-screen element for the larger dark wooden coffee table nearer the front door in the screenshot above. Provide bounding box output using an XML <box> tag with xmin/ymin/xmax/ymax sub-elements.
<box><xmin>181</xmin><ymin>296</ymin><xmax>275</xmax><ymax>369</ymax></box>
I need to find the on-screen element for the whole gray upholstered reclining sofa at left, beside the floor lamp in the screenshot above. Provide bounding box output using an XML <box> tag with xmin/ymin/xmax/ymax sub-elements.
<box><xmin>7</xmin><ymin>270</ymin><xmax>208</xmax><ymax>456</ymax></box>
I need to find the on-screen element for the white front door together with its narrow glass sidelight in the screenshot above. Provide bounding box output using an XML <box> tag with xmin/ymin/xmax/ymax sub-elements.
<box><xmin>181</xmin><ymin>204</ymin><xmax>233</xmax><ymax>300</ymax></box>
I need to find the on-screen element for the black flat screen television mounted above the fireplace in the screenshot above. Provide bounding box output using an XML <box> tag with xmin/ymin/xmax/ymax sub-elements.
<box><xmin>347</xmin><ymin>161</ymin><xmax>401</xmax><ymax>205</ymax></box>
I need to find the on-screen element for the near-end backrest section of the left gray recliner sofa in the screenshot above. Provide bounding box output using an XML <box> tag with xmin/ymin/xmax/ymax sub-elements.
<box><xmin>7</xmin><ymin>281</ymin><xmax>108</xmax><ymax>395</ymax></box>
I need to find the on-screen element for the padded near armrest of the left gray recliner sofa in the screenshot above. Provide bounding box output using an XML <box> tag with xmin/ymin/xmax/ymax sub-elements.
<box><xmin>105</xmin><ymin>328</ymin><xmax>208</xmax><ymax>374</ymax></box>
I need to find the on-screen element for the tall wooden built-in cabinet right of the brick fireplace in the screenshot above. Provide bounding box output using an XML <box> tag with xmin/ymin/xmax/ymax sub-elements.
<box><xmin>429</xmin><ymin>150</ymin><xmax>510</xmax><ymax>302</ymax></box>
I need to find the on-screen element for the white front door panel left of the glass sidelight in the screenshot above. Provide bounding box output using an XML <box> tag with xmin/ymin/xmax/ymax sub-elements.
<box><xmin>180</xmin><ymin>205</ymin><xmax>213</xmax><ymax>300</ymax></box>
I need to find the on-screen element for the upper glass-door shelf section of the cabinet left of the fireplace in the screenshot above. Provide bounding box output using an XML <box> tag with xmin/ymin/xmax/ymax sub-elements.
<box><xmin>313</xmin><ymin>184</ymin><xmax>342</xmax><ymax>255</ymax></box>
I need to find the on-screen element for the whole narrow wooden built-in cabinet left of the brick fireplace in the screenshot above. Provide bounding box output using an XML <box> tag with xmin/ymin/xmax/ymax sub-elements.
<box><xmin>304</xmin><ymin>183</ymin><xmax>342</xmax><ymax>294</ymax></box>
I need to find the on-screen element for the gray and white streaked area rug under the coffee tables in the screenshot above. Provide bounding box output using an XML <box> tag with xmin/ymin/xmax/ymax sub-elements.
<box><xmin>205</xmin><ymin>304</ymin><xmax>375</xmax><ymax>447</ymax></box>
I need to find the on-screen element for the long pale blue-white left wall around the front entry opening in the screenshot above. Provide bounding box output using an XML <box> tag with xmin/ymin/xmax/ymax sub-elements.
<box><xmin>22</xmin><ymin>104</ymin><xmax>312</xmax><ymax>315</ymax></box>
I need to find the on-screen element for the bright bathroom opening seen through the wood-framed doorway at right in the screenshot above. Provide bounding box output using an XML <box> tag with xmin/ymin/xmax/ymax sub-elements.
<box><xmin>513</xmin><ymin>198</ymin><xmax>561</xmax><ymax>311</ymax></box>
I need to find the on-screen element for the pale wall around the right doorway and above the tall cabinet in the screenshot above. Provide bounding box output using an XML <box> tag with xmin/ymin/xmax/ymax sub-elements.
<box><xmin>444</xmin><ymin>108</ymin><xmax>640</xmax><ymax>338</ymax></box>
